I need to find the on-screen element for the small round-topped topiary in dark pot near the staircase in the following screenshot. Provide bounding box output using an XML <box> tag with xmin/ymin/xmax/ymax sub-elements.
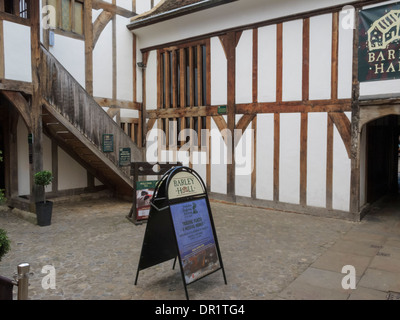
<box><xmin>34</xmin><ymin>170</ymin><xmax>53</xmax><ymax>227</ymax></box>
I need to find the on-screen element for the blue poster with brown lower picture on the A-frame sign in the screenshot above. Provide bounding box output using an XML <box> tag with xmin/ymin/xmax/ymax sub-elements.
<box><xmin>170</xmin><ymin>198</ymin><xmax>221</xmax><ymax>284</ymax></box>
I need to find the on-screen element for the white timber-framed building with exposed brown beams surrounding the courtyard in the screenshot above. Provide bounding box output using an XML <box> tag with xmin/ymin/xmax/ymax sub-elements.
<box><xmin>0</xmin><ymin>0</ymin><xmax>400</xmax><ymax>220</ymax></box>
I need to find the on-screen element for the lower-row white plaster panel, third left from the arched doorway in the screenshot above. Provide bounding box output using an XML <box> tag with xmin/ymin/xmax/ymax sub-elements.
<box><xmin>279</xmin><ymin>113</ymin><xmax>301</xmax><ymax>203</ymax></box>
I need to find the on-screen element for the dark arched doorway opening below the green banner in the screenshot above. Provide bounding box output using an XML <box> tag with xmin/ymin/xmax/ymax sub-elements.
<box><xmin>366</xmin><ymin>115</ymin><xmax>400</xmax><ymax>203</ymax></box>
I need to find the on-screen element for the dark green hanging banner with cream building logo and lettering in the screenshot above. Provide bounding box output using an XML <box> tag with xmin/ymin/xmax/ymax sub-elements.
<box><xmin>358</xmin><ymin>2</ymin><xmax>400</xmax><ymax>82</ymax></box>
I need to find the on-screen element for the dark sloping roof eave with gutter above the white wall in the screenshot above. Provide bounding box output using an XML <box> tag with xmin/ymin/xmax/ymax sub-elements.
<box><xmin>127</xmin><ymin>0</ymin><xmax>238</xmax><ymax>30</ymax></box>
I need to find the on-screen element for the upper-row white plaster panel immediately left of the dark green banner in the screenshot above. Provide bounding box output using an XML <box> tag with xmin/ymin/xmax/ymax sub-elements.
<box><xmin>338</xmin><ymin>12</ymin><xmax>353</xmax><ymax>99</ymax></box>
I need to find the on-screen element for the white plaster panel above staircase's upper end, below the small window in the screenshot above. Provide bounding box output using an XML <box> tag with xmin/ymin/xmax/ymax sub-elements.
<box><xmin>49</xmin><ymin>34</ymin><xmax>85</xmax><ymax>87</ymax></box>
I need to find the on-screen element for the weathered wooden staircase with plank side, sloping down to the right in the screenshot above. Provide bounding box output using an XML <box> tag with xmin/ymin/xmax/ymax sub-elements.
<box><xmin>40</xmin><ymin>47</ymin><xmax>143</xmax><ymax>196</ymax></box>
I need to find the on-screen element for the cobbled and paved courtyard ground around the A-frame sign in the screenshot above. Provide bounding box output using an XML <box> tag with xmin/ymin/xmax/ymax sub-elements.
<box><xmin>0</xmin><ymin>192</ymin><xmax>400</xmax><ymax>300</ymax></box>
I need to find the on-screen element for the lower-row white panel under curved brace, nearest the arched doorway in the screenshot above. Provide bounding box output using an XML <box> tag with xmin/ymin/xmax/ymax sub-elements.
<box><xmin>332</xmin><ymin>126</ymin><xmax>351</xmax><ymax>211</ymax></box>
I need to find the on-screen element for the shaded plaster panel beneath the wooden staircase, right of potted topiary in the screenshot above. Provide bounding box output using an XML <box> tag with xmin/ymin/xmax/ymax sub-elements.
<box><xmin>58</xmin><ymin>148</ymin><xmax>87</xmax><ymax>190</ymax></box>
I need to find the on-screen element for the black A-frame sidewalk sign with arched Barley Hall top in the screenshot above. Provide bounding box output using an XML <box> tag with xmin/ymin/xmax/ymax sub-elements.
<box><xmin>135</xmin><ymin>166</ymin><xmax>227</xmax><ymax>300</ymax></box>
